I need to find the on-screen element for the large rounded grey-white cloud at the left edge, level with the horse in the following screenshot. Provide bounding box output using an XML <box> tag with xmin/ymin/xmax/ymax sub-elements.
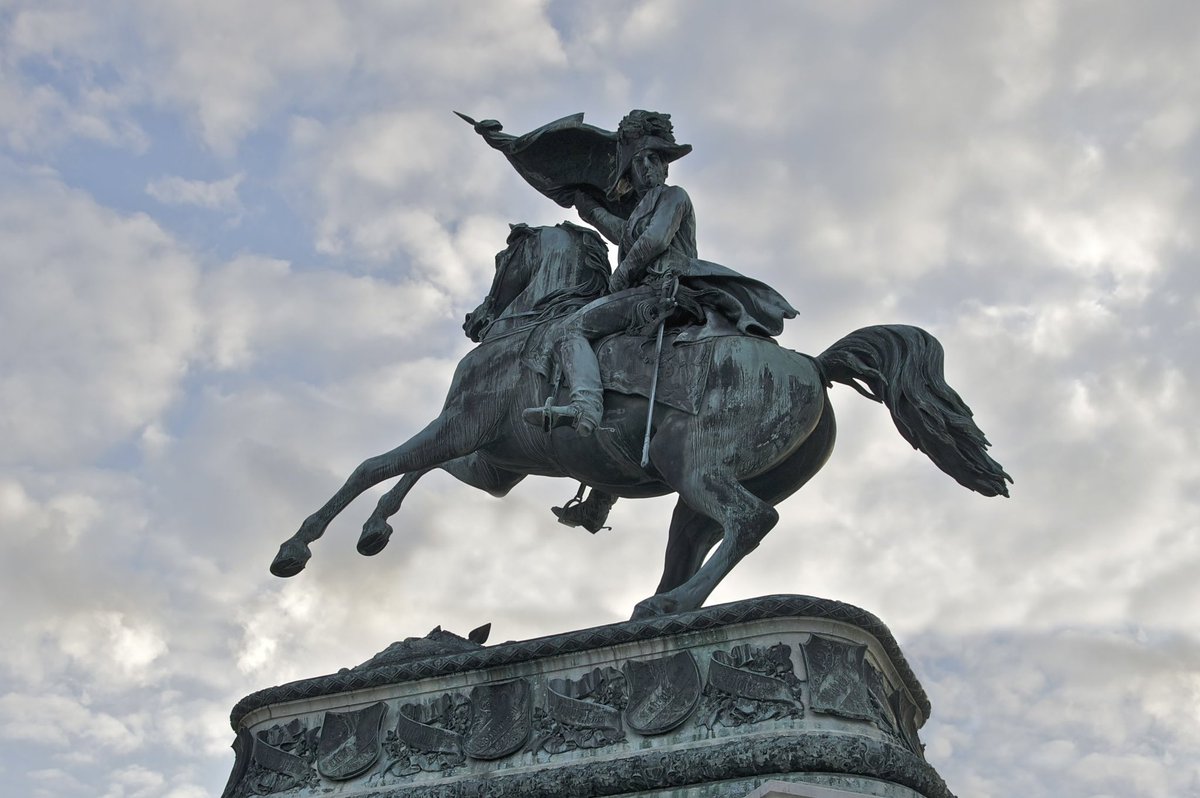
<box><xmin>0</xmin><ymin>168</ymin><xmax>202</xmax><ymax>464</ymax></box>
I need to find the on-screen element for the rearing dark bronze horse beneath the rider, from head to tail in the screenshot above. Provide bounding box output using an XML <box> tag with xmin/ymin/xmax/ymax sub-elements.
<box><xmin>271</xmin><ymin>222</ymin><xmax>1012</xmax><ymax>618</ymax></box>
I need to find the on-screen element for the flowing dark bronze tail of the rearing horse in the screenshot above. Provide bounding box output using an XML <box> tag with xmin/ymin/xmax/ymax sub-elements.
<box><xmin>816</xmin><ymin>324</ymin><xmax>1013</xmax><ymax>496</ymax></box>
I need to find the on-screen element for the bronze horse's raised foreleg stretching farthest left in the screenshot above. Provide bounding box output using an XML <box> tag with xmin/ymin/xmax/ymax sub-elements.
<box><xmin>271</xmin><ymin>410</ymin><xmax>484</xmax><ymax>576</ymax></box>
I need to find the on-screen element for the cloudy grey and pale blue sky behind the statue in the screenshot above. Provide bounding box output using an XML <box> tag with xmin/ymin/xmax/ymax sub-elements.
<box><xmin>0</xmin><ymin>0</ymin><xmax>1200</xmax><ymax>798</ymax></box>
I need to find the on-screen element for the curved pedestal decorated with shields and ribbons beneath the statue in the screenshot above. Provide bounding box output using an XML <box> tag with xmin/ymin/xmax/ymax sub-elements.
<box><xmin>224</xmin><ymin>595</ymin><xmax>953</xmax><ymax>798</ymax></box>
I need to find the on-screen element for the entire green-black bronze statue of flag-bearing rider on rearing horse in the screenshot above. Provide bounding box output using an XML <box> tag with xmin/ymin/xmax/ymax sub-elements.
<box><xmin>271</xmin><ymin>112</ymin><xmax>1012</xmax><ymax>618</ymax></box>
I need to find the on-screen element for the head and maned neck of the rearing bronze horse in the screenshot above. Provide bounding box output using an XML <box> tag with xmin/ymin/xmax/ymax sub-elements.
<box><xmin>463</xmin><ymin>222</ymin><xmax>610</xmax><ymax>341</ymax></box>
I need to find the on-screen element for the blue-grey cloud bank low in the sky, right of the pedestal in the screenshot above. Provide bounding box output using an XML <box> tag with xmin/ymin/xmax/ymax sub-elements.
<box><xmin>914</xmin><ymin>629</ymin><xmax>1200</xmax><ymax>798</ymax></box>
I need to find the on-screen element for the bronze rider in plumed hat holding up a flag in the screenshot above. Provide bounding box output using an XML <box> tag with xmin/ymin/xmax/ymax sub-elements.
<box><xmin>482</xmin><ymin>110</ymin><xmax>796</xmax><ymax>533</ymax></box>
